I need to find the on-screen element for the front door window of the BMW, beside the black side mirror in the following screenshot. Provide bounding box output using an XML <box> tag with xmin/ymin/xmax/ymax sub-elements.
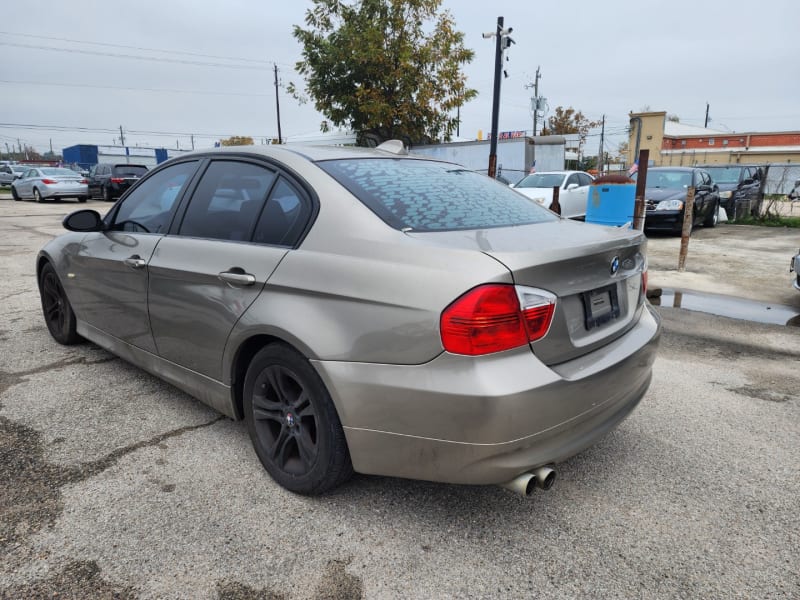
<box><xmin>111</xmin><ymin>161</ymin><xmax>197</xmax><ymax>234</ymax></box>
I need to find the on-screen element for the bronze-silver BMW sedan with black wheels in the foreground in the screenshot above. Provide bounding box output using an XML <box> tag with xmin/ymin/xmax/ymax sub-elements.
<box><xmin>36</xmin><ymin>145</ymin><xmax>660</xmax><ymax>494</ymax></box>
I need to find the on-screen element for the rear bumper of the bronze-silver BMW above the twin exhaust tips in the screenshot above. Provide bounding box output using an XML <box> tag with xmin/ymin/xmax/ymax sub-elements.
<box><xmin>314</xmin><ymin>305</ymin><xmax>661</xmax><ymax>484</ymax></box>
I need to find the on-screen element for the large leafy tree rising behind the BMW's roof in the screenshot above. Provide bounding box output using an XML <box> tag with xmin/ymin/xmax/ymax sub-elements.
<box><xmin>288</xmin><ymin>0</ymin><xmax>477</xmax><ymax>145</ymax></box>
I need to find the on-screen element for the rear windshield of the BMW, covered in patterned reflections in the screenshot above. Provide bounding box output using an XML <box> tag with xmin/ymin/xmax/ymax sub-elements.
<box><xmin>318</xmin><ymin>158</ymin><xmax>558</xmax><ymax>231</ymax></box>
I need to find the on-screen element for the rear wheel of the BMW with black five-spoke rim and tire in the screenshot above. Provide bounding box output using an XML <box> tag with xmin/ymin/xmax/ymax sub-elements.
<box><xmin>243</xmin><ymin>344</ymin><xmax>353</xmax><ymax>495</ymax></box>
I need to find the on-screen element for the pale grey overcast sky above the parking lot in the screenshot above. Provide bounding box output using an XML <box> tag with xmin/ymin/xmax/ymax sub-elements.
<box><xmin>0</xmin><ymin>0</ymin><xmax>800</xmax><ymax>151</ymax></box>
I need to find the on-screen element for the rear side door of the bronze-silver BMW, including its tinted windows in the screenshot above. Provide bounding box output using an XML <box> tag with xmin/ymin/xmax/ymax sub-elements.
<box><xmin>149</xmin><ymin>159</ymin><xmax>311</xmax><ymax>380</ymax></box>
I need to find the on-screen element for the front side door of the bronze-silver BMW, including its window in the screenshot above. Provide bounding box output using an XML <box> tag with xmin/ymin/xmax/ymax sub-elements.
<box><xmin>65</xmin><ymin>160</ymin><xmax>200</xmax><ymax>352</ymax></box>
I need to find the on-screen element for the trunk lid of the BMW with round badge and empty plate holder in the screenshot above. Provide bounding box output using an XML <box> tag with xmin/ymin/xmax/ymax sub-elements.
<box><xmin>408</xmin><ymin>220</ymin><xmax>646</xmax><ymax>365</ymax></box>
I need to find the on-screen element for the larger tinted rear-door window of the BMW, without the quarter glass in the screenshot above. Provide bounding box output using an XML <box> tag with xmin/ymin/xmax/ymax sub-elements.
<box><xmin>178</xmin><ymin>160</ymin><xmax>276</xmax><ymax>241</ymax></box>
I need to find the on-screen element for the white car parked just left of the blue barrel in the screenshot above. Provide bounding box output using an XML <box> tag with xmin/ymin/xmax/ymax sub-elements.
<box><xmin>511</xmin><ymin>171</ymin><xmax>594</xmax><ymax>219</ymax></box>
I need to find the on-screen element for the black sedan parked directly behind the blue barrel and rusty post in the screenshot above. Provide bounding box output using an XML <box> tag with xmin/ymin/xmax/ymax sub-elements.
<box><xmin>637</xmin><ymin>167</ymin><xmax>719</xmax><ymax>234</ymax></box>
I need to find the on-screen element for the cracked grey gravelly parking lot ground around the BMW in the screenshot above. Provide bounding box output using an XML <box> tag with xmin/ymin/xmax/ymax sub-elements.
<box><xmin>0</xmin><ymin>198</ymin><xmax>800</xmax><ymax>599</ymax></box>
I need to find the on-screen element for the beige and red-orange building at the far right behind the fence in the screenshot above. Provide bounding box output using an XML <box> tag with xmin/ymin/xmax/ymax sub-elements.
<box><xmin>628</xmin><ymin>111</ymin><xmax>800</xmax><ymax>166</ymax></box>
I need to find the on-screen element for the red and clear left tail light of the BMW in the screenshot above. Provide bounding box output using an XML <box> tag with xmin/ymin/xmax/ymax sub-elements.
<box><xmin>439</xmin><ymin>284</ymin><xmax>556</xmax><ymax>356</ymax></box>
